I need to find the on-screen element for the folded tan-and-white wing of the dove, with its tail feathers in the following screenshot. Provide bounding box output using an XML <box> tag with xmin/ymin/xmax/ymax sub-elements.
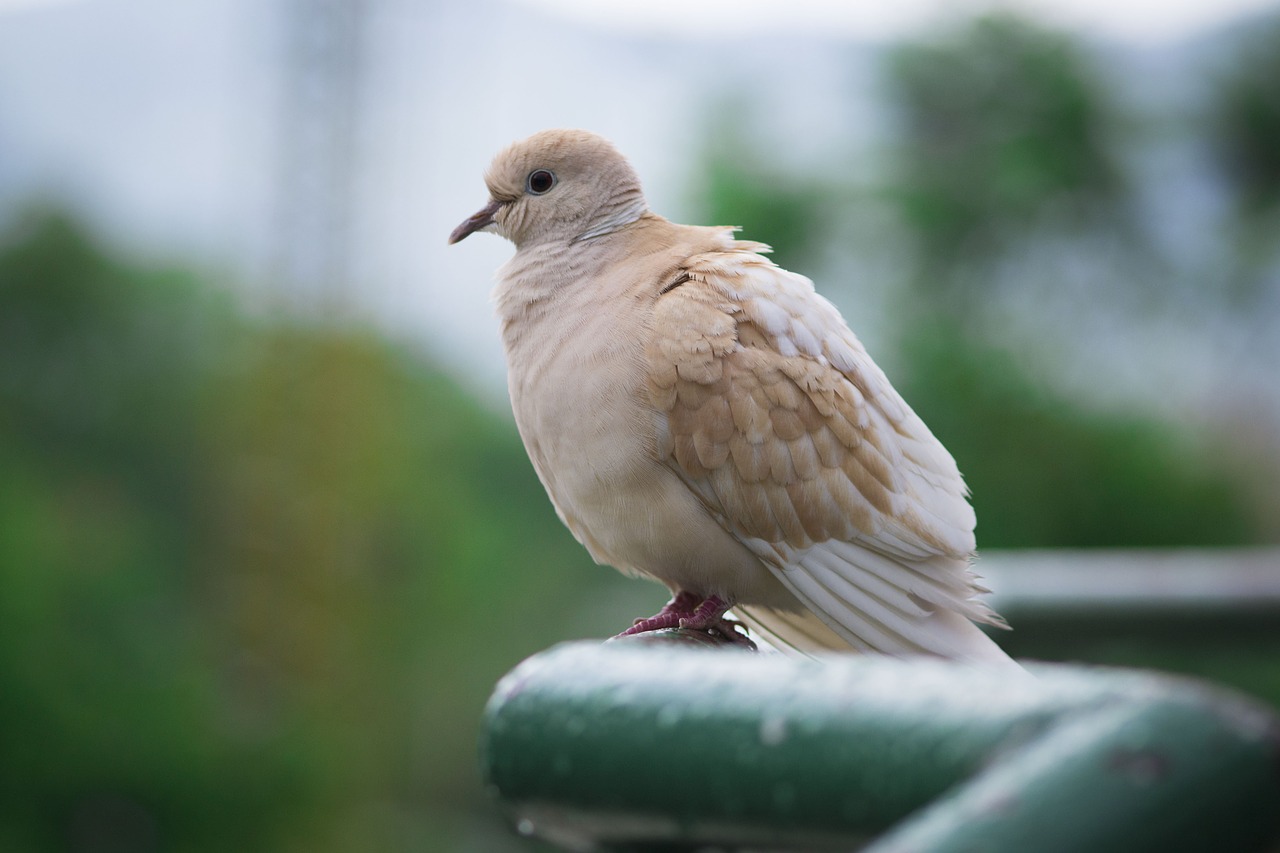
<box><xmin>646</xmin><ymin>243</ymin><xmax>1007</xmax><ymax>661</ymax></box>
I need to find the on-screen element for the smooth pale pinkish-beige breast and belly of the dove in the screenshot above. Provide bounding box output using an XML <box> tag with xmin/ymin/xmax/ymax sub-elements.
<box><xmin>497</xmin><ymin>239</ymin><xmax>794</xmax><ymax>606</ymax></box>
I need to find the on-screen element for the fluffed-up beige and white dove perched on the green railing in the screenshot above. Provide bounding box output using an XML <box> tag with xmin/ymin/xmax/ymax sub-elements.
<box><xmin>448</xmin><ymin>129</ymin><xmax>1016</xmax><ymax>666</ymax></box>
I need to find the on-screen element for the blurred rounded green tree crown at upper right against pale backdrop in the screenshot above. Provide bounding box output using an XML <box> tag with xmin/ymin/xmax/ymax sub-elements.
<box><xmin>886</xmin><ymin>14</ymin><xmax>1124</xmax><ymax>308</ymax></box>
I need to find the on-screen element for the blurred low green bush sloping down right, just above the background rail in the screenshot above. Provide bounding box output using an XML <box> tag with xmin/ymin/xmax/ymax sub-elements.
<box><xmin>897</xmin><ymin>323</ymin><xmax>1258</xmax><ymax>548</ymax></box>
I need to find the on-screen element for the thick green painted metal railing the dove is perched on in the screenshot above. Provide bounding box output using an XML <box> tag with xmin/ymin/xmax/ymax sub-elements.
<box><xmin>481</xmin><ymin>631</ymin><xmax>1280</xmax><ymax>853</ymax></box>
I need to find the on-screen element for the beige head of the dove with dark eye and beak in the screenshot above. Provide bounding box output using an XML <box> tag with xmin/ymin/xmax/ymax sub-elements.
<box><xmin>449</xmin><ymin>131</ymin><xmax>646</xmax><ymax>248</ymax></box>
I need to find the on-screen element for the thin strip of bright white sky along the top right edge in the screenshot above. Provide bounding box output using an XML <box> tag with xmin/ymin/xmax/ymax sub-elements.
<box><xmin>509</xmin><ymin>0</ymin><xmax>1277</xmax><ymax>42</ymax></box>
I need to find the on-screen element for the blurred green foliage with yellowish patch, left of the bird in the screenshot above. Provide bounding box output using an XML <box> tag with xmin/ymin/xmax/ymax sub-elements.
<box><xmin>0</xmin><ymin>215</ymin><xmax>599</xmax><ymax>850</ymax></box>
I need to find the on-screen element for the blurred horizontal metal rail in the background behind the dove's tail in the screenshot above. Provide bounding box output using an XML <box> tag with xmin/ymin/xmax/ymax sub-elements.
<box><xmin>974</xmin><ymin>547</ymin><xmax>1280</xmax><ymax>655</ymax></box>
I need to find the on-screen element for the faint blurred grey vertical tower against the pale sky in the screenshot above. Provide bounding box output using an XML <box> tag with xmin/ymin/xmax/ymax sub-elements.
<box><xmin>271</xmin><ymin>0</ymin><xmax>366</xmax><ymax>316</ymax></box>
